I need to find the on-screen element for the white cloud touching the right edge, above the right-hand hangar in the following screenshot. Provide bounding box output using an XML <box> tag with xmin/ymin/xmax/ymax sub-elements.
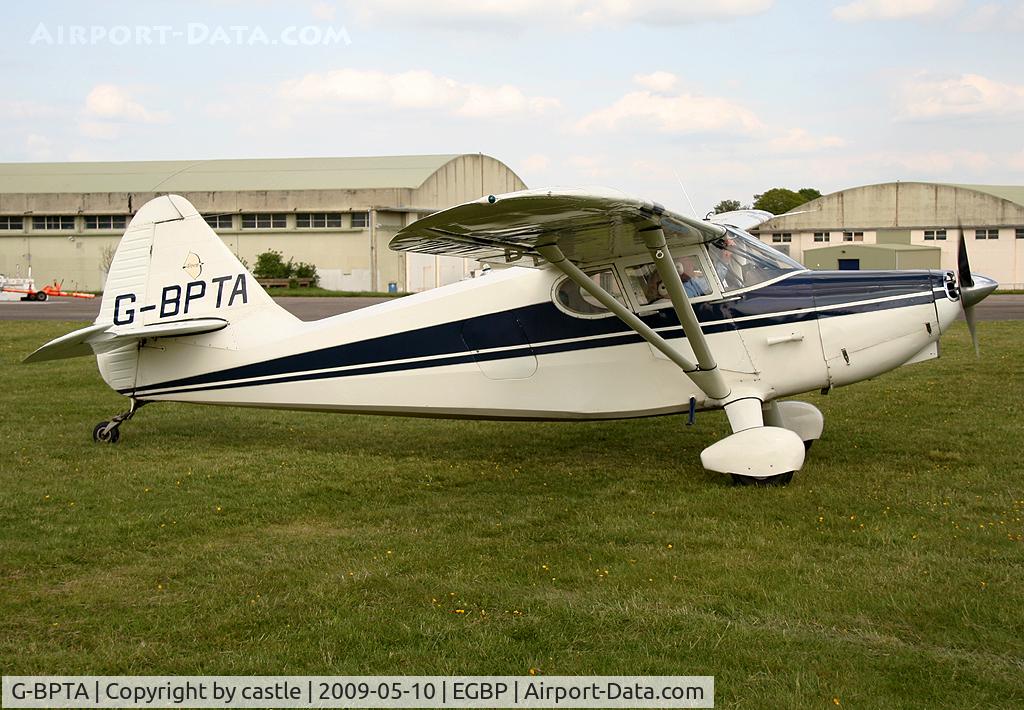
<box><xmin>898</xmin><ymin>74</ymin><xmax>1024</xmax><ymax>120</ymax></box>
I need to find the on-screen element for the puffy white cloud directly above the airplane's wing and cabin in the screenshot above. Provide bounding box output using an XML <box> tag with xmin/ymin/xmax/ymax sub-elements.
<box><xmin>575</xmin><ymin>91</ymin><xmax>763</xmax><ymax>134</ymax></box>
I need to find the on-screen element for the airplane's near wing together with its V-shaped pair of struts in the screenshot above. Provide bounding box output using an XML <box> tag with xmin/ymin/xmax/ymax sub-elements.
<box><xmin>390</xmin><ymin>190</ymin><xmax>730</xmax><ymax>400</ymax></box>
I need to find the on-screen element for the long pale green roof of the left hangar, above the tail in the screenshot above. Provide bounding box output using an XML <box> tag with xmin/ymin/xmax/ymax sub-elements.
<box><xmin>0</xmin><ymin>154</ymin><xmax>497</xmax><ymax>193</ymax></box>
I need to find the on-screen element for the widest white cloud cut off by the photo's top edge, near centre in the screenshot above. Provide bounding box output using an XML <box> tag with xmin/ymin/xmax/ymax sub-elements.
<box><xmin>351</xmin><ymin>0</ymin><xmax>774</xmax><ymax>28</ymax></box>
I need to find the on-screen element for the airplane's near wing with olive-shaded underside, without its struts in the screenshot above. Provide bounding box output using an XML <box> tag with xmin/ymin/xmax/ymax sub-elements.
<box><xmin>390</xmin><ymin>189</ymin><xmax>725</xmax><ymax>266</ymax></box>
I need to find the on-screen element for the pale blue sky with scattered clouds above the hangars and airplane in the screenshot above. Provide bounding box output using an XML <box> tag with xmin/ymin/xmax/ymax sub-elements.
<box><xmin>0</xmin><ymin>0</ymin><xmax>1024</xmax><ymax>215</ymax></box>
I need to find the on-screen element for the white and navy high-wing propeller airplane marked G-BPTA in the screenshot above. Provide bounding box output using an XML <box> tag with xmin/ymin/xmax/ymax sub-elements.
<box><xmin>26</xmin><ymin>190</ymin><xmax>996</xmax><ymax>484</ymax></box>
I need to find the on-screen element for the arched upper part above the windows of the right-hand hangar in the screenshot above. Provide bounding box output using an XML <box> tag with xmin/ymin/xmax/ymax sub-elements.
<box><xmin>757</xmin><ymin>182</ymin><xmax>1024</xmax><ymax>233</ymax></box>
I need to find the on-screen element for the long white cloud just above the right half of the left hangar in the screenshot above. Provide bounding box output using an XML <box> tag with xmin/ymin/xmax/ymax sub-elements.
<box><xmin>282</xmin><ymin>69</ymin><xmax>559</xmax><ymax>118</ymax></box>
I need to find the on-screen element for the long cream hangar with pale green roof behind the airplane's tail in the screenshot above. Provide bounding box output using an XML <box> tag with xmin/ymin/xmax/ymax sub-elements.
<box><xmin>0</xmin><ymin>154</ymin><xmax>525</xmax><ymax>291</ymax></box>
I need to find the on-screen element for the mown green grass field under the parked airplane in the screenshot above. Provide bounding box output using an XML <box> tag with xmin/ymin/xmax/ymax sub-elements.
<box><xmin>0</xmin><ymin>323</ymin><xmax>1024</xmax><ymax>708</ymax></box>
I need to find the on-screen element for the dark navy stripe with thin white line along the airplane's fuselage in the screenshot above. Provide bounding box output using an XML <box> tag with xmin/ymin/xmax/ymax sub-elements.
<box><xmin>121</xmin><ymin>272</ymin><xmax>935</xmax><ymax>398</ymax></box>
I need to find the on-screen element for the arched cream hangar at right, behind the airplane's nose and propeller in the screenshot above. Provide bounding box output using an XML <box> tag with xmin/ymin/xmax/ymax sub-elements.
<box><xmin>756</xmin><ymin>182</ymin><xmax>1024</xmax><ymax>289</ymax></box>
